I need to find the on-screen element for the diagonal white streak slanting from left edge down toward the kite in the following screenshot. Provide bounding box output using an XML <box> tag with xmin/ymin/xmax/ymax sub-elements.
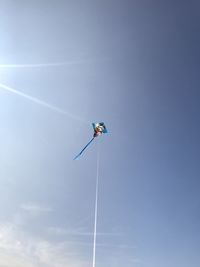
<box><xmin>0</xmin><ymin>83</ymin><xmax>86</xmax><ymax>123</ymax></box>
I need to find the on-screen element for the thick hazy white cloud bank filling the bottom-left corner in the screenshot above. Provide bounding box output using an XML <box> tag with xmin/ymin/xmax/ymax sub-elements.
<box><xmin>0</xmin><ymin>223</ymin><xmax>88</xmax><ymax>267</ymax></box>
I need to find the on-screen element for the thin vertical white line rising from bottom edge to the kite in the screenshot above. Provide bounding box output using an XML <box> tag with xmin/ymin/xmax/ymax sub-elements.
<box><xmin>92</xmin><ymin>142</ymin><xmax>100</xmax><ymax>267</ymax></box>
